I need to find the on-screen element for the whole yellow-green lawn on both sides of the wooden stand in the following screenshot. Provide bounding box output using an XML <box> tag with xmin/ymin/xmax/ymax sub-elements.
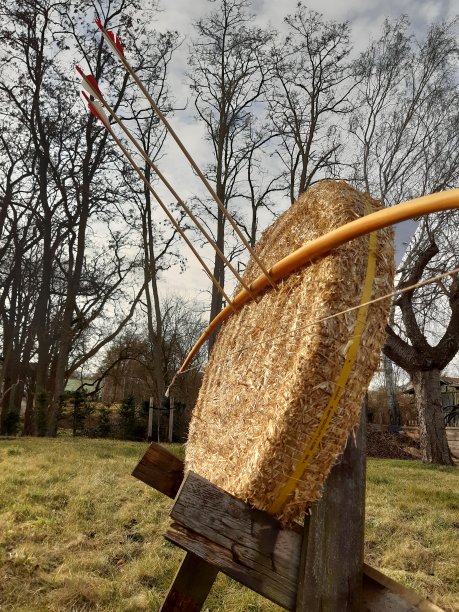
<box><xmin>0</xmin><ymin>438</ymin><xmax>459</xmax><ymax>612</ymax></box>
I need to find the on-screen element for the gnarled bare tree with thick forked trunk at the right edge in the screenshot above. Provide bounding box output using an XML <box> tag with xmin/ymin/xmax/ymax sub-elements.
<box><xmin>384</xmin><ymin>214</ymin><xmax>459</xmax><ymax>465</ymax></box>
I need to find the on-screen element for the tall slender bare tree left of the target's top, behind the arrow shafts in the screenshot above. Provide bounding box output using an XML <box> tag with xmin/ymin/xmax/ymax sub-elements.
<box><xmin>189</xmin><ymin>0</ymin><xmax>271</xmax><ymax>348</ymax></box>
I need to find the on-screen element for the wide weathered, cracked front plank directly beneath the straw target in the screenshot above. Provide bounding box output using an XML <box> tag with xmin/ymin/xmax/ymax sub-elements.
<box><xmin>166</xmin><ymin>472</ymin><xmax>302</xmax><ymax>609</ymax></box>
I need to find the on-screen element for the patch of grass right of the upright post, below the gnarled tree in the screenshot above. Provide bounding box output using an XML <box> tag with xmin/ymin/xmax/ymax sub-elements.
<box><xmin>365</xmin><ymin>459</ymin><xmax>459</xmax><ymax>611</ymax></box>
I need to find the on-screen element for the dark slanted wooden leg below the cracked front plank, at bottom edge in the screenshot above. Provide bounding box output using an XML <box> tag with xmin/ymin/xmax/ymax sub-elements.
<box><xmin>161</xmin><ymin>552</ymin><xmax>218</xmax><ymax>612</ymax></box>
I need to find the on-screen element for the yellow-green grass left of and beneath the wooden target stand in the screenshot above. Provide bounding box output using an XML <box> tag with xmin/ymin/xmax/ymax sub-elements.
<box><xmin>0</xmin><ymin>438</ymin><xmax>279</xmax><ymax>612</ymax></box>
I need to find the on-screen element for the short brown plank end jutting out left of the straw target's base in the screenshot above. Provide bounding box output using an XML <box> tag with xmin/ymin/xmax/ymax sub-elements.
<box><xmin>132</xmin><ymin>442</ymin><xmax>183</xmax><ymax>499</ymax></box>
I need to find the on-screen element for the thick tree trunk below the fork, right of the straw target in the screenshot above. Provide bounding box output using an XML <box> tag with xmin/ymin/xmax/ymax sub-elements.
<box><xmin>411</xmin><ymin>370</ymin><xmax>452</xmax><ymax>465</ymax></box>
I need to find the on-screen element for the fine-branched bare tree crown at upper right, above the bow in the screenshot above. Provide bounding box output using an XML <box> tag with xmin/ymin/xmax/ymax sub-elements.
<box><xmin>350</xmin><ymin>17</ymin><xmax>459</xmax><ymax>205</ymax></box>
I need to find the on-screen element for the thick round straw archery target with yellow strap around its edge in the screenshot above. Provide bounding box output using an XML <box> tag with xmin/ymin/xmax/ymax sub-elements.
<box><xmin>186</xmin><ymin>181</ymin><xmax>394</xmax><ymax>522</ymax></box>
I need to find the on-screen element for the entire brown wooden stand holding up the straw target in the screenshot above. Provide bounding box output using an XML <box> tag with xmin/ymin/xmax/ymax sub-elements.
<box><xmin>133</xmin><ymin>417</ymin><xmax>441</xmax><ymax>612</ymax></box>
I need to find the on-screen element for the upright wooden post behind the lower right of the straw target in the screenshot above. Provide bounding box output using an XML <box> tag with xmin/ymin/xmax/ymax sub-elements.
<box><xmin>296</xmin><ymin>409</ymin><xmax>366</xmax><ymax>612</ymax></box>
